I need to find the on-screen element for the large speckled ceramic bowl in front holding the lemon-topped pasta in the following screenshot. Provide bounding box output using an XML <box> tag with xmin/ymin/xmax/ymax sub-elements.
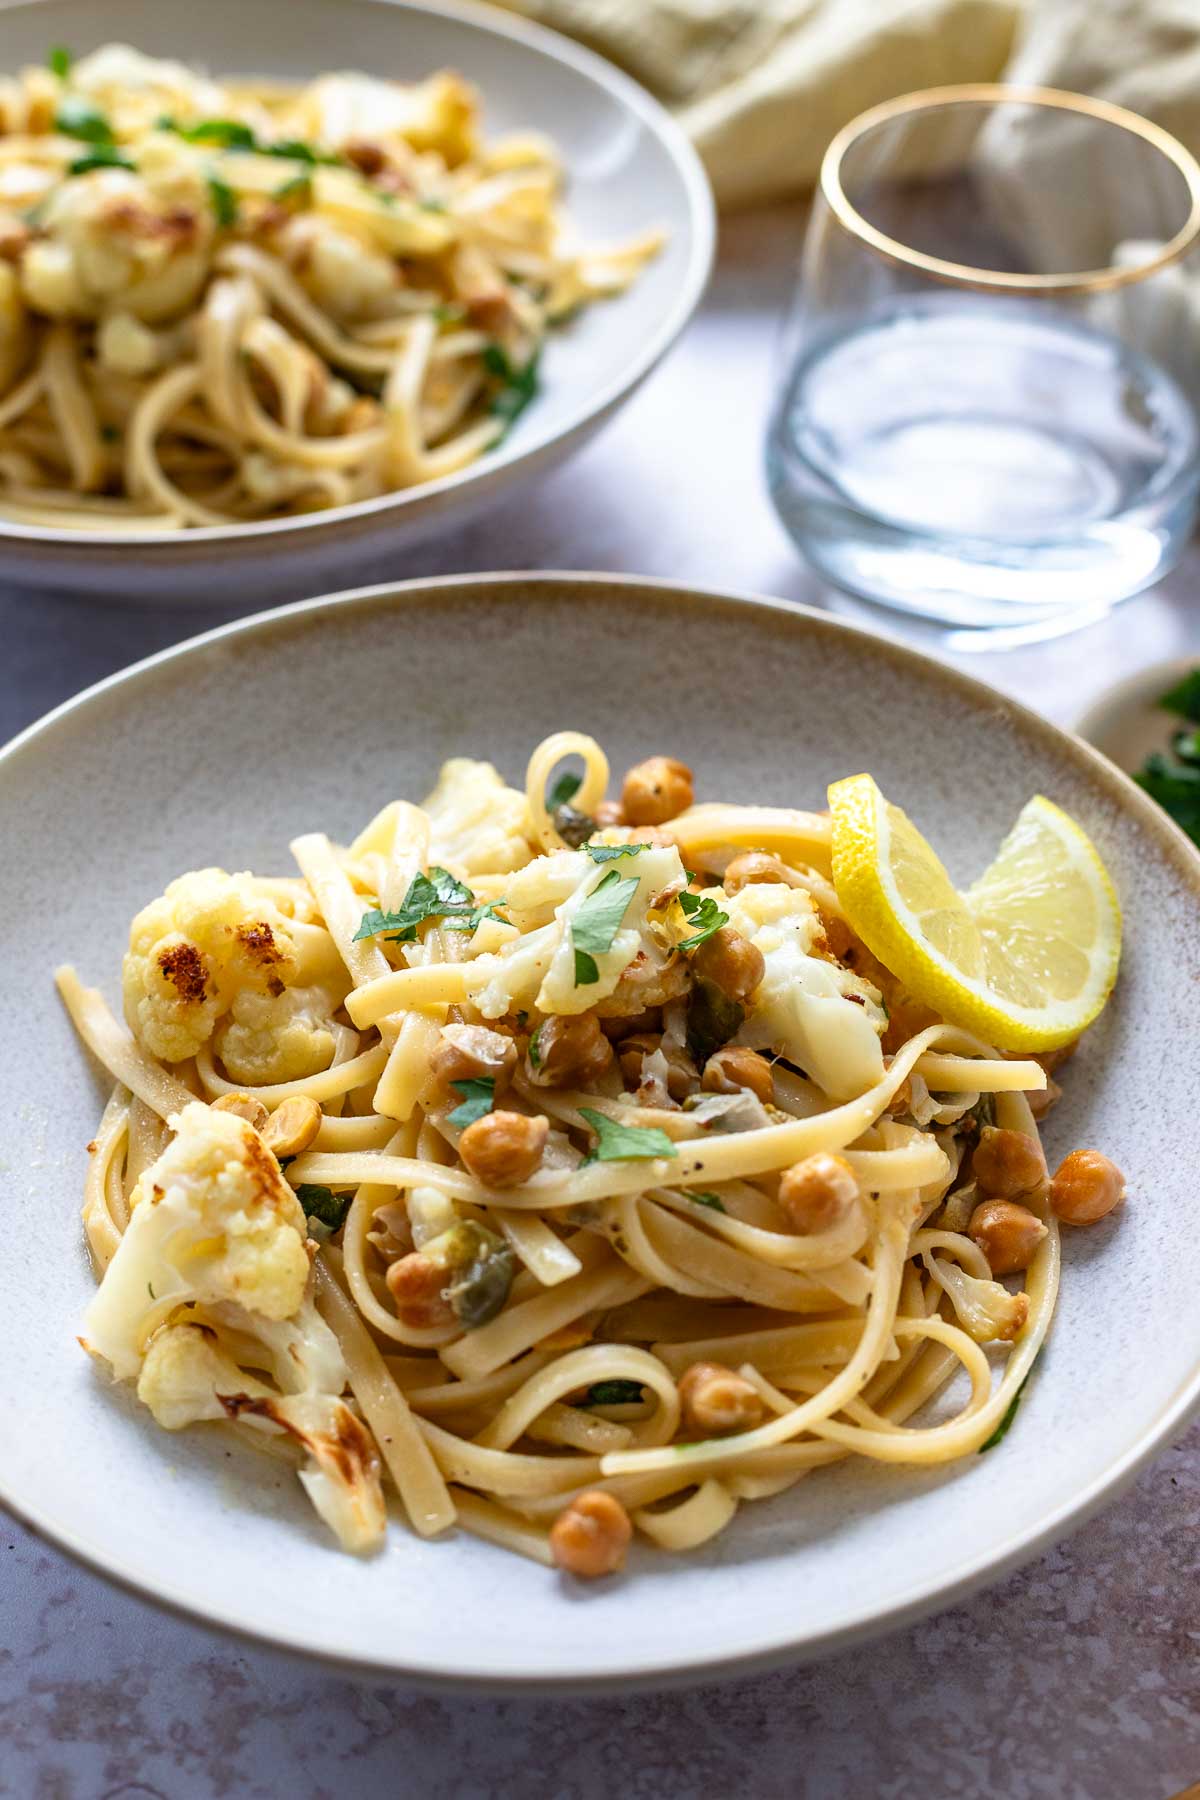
<box><xmin>0</xmin><ymin>576</ymin><xmax>1200</xmax><ymax>1688</ymax></box>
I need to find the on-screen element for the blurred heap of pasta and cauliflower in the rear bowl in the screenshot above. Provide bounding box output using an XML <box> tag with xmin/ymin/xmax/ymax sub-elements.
<box><xmin>0</xmin><ymin>43</ymin><xmax>660</xmax><ymax>531</ymax></box>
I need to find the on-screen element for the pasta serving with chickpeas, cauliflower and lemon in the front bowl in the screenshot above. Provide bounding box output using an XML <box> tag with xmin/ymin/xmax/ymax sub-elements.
<box><xmin>59</xmin><ymin>733</ymin><xmax>1124</xmax><ymax>1577</ymax></box>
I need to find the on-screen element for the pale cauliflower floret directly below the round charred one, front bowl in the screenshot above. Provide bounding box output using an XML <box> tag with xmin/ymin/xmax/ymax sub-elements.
<box><xmin>83</xmin><ymin>1100</ymin><xmax>309</xmax><ymax>1381</ymax></box>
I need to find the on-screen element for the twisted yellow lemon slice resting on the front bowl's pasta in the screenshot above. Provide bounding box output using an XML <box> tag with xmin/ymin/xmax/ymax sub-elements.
<box><xmin>829</xmin><ymin>776</ymin><xmax>1121</xmax><ymax>1051</ymax></box>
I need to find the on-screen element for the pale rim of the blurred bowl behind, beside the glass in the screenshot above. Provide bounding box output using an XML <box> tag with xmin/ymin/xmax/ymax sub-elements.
<box><xmin>0</xmin><ymin>0</ymin><xmax>716</xmax><ymax>567</ymax></box>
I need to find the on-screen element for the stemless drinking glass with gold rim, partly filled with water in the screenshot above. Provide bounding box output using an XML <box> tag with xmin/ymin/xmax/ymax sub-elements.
<box><xmin>766</xmin><ymin>85</ymin><xmax>1200</xmax><ymax>630</ymax></box>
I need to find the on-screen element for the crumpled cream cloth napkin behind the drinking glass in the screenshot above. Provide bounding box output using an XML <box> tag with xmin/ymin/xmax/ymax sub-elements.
<box><xmin>485</xmin><ymin>0</ymin><xmax>1200</xmax><ymax>207</ymax></box>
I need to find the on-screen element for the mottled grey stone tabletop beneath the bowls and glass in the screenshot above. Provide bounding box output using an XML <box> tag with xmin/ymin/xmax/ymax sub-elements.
<box><xmin>0</xmin><ymin>211</ymin><xmax>1200</xmax><ymax>1800</ymax></box>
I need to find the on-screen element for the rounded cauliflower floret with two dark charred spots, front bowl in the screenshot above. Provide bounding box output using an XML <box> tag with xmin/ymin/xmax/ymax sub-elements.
<box><xmin>122</xmin><ymin>869</ymin><xmax>307</xmax><ymax>1080</ymax></box>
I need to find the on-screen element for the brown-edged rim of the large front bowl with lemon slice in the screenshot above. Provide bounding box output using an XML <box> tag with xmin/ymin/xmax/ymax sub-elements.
<box><xmin>0</xmin><ymin>571</ymin><xmax>1200</xmax><ymax>1696</ymax></box>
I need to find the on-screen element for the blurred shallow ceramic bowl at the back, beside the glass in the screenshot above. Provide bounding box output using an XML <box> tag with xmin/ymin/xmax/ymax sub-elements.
<box><xmin>0</xmin><ymin>0</ymin><xmax>714</xmax><ymax>605</ymax></box>
